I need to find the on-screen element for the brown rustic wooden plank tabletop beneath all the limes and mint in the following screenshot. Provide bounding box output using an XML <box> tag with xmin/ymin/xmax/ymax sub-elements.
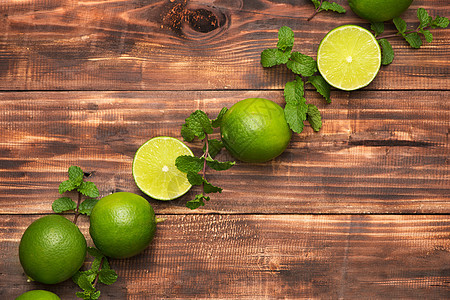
<box><xmin>0</xmin><ymin>0</ymin><xmax>450</xmax><ymax>299</ymax></box>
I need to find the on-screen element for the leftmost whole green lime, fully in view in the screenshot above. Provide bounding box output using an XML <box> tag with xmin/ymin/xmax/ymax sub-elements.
<box><xmin>19</xmin><ymin>215</ymin><xmax>86</xmax><ymax>284</ymax></box>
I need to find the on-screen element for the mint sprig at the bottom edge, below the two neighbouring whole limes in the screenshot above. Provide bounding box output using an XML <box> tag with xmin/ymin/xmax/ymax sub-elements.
<box><xmin>72</xmin><ymin>247</ymin><xmax>117</xmax><ymax>300</ymax></box>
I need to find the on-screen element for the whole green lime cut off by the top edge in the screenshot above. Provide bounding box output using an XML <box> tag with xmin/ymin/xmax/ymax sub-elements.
<box><xmin>348</xmin><ymin>0</ymin><xmax>413</xmax><ymax>22</ymax></box>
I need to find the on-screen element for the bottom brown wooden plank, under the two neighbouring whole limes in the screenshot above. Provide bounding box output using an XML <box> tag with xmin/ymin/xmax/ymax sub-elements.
<box><xmin>0</xmin><ymin>215</ymin><xmax>450</xmax><ymax>299</ymax></box>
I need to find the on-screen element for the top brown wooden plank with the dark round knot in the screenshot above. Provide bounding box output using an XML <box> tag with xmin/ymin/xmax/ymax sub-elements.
<box><xmin>0</xmin><ymin>0</ymin><xmax>450</xmax><ymax>90</ymax></box>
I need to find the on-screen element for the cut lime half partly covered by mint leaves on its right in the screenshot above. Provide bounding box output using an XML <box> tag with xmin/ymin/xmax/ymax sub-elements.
<box><xmin>133</xmin><ymin>136</ymin><xmax>193</xmax><ymax>200</ymax></box>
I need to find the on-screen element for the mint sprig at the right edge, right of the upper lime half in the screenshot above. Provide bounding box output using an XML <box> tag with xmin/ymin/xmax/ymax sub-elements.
<box><xmin>370</xmin><ymin>7</ymin><xmax>449</xmax><ymax>65</ymax></box>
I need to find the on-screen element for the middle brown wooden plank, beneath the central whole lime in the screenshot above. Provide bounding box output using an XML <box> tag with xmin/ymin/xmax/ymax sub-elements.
<box><xmin>0</xmin><ymin>91</ymin><xmax>450</xmax><ymax>214</ymax></box>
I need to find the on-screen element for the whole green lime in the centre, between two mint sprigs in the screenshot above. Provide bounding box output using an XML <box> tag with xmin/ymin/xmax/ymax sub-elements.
<box><xmin>220</xmin><ymin>98</ymin><xmax>292</xmax><ymax>162</ymax></box>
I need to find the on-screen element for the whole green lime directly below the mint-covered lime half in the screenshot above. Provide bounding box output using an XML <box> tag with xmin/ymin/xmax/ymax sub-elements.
<box><xmin>89</xmin><ymin>192</ymin><xmax>156</xmax><ymax>258</ymax></box>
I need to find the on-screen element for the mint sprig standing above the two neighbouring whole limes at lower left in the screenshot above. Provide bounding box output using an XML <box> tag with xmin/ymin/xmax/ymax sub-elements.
<box><xmin>52</xmin><ymin>166</ymin><xmax>100</xmax><ymax>223</ymax></box>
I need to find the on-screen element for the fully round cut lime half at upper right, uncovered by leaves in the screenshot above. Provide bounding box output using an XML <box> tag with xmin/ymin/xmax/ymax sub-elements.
<box><xmin>317</xmin><ymin>25</ymin><xmax>381</xmax><ymax>91</ymax></box>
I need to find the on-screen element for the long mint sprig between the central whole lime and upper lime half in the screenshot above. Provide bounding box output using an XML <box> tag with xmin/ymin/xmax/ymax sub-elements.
<box><xmin>261</xmin><ymin>26</ymin><xmax>331</xmax><ymax>133</ymax></box>
